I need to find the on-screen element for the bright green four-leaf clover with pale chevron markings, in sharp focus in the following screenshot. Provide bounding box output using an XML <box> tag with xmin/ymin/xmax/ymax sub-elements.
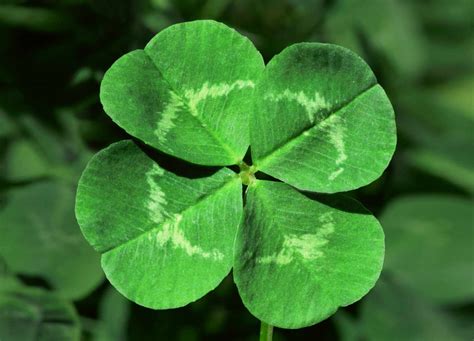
<box><xmin>76</xmin><ymin>21</ymin><xmax>396</xmax><ymax>331</ymax></box>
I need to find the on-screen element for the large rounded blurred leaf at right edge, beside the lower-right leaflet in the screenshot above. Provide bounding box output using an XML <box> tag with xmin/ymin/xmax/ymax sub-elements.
<box><xmin>381</xmin><ymin>194</ymin><xmax>474</xmax><ymax>303</ymax></box>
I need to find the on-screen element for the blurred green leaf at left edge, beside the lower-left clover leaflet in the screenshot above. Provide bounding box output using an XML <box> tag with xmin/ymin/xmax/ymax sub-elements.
<box><xmin>0</xmin><ymin>181</ymin><xmax>103</xmax><ymax>299</ymax></box>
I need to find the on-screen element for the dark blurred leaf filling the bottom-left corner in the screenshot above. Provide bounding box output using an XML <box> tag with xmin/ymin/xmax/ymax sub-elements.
<box><xmin>0</xmin><ymin>282</ymin><xmax>80</xmax><ymax>341</ymax></box>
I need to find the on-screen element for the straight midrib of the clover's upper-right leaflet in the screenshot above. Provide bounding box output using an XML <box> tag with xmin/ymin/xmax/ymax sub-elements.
<box><xmin>254</xmin><ymin>82</ymin><xmax>378</xmax><ymax>171</ymax></box>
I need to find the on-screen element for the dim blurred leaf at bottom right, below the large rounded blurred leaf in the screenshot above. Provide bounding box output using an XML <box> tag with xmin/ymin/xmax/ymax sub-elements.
<box><xmin>359</xmin><ymin>278</ymin><xmax>462</xmax><ymax>341</ymax></box>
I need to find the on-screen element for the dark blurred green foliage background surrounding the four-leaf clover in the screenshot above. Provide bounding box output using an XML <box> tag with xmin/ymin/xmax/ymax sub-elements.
<box><xmin>0</xmin><ymin>0</ymin><xmax>474</xmax><ymax>341</ymax></box>
